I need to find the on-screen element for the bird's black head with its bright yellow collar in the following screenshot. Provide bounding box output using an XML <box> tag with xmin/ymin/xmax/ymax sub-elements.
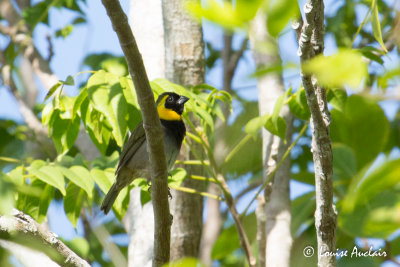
<box><xmin>156</xmin><ymin>92</ymin><xmax>189</xmax><ymax>121</ymax></box>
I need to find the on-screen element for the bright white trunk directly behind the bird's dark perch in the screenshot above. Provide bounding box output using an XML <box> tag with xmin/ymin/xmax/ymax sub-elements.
<box><xmin>124</xmin><ymin>0</ymin><xmax>165</xmax><ymax>267</ymax></box>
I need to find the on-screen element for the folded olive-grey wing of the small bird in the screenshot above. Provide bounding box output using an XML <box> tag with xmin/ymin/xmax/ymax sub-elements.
<box><xmin>115</xmin><ymin>122</ymin><xmax>146</xmax><ymax>174</ymax></box>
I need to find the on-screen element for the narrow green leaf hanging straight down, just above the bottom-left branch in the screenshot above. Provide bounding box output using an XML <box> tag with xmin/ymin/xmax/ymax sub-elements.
<box><xmin>64</xmin><ymin>183</ymin><xmax>85</xmax><ymax>228</ymax></box>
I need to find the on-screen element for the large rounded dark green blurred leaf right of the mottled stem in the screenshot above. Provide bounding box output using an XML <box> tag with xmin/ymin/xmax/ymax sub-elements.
<box><xmin>331</xmin><ymin>95</ymin><xmax>389</xmax><ymax>169</ymax></box>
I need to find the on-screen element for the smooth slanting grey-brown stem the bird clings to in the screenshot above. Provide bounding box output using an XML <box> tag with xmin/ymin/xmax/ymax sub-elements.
<box><xmin>102</xmin><ymin>0</ymin><xmax>171</xmax><ymax>266</ymax></box>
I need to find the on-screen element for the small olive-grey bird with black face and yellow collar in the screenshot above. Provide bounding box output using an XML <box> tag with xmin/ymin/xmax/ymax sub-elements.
<box><xmin>100</xmin><ymin>92</ymin><xmax>189</xmax><ymax>214</ymax></box>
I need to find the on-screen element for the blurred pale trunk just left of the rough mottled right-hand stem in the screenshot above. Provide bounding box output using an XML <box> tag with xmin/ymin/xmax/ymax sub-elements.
<box><xmin>250</xmin><ymin>10</ymin><xmax>293</xmax><ymax>267</ymax></box>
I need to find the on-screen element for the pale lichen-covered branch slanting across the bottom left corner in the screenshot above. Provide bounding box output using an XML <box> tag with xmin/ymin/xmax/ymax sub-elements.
<box><xmin>0</xmin><ymin>210</ymin><xmax>90</xmax><ymax>267</ymax></box>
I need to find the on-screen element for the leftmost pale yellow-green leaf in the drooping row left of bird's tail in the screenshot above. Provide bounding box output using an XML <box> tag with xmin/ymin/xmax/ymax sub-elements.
<box><xmin>29</xmin><ymin>166</ymin><xmax>66</xmax><ymax>196</ymax></box>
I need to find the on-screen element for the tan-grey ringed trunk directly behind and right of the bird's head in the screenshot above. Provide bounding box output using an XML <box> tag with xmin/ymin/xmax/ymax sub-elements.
<box><xmin>162</xmin><ymin>0</ymin><xmax>205</xmax><ymax>261</ymax></box>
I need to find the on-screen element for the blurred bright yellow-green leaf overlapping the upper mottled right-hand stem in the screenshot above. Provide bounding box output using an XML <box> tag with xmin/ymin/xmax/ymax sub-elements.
<box><xmin>302</xmin><ymin>49</ymin><xmax>368</xmax><ymax>89</ymax></box>
